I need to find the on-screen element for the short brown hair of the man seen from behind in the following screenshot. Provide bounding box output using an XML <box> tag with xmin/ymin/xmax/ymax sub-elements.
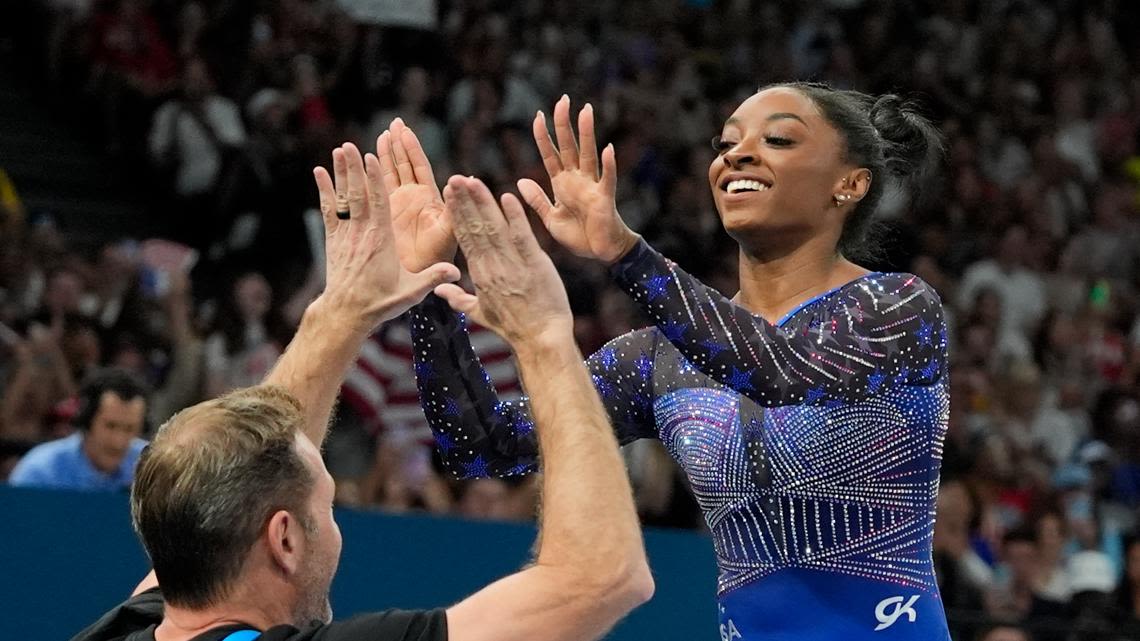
<box><xmin>131</xmin><ymin>386</ymin><xmax>315</xmax><ymax>609</ymax></box>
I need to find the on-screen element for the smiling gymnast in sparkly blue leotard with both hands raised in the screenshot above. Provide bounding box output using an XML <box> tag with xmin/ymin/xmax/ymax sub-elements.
<box><xmin>377</xmin><ymin>82</ymin><xmax>948</xmax><ymax>641</ymax></box>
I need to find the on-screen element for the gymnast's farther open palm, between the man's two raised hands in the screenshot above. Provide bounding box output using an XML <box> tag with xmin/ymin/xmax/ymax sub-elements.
<box><xmin>376</xmin><ymin>119</ymin><xmax>455</xmax><ymax>271</ymax></box>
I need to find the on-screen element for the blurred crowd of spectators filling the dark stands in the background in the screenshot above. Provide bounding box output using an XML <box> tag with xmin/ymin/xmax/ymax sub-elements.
<box><xmin>0</xmin><ymin>0</ymin><xmax>1140</xmax><ymax>641</ymax></box>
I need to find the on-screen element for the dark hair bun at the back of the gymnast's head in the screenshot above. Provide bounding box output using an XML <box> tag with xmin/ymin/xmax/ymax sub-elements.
<box><xmin>869</xmin><ymin>94</ymin><xmax>945</xmax><ymax>181</ymax></box>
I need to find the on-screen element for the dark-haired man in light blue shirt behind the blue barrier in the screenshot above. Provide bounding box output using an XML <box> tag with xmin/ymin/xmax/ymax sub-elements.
<box><xmin>8</xmin><ymin>370</ymin><xmax>147</xmax><ymax>490</ymax></box>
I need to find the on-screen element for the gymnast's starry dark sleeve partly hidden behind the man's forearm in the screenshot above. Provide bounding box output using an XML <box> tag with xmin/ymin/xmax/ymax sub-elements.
<box><xmin>410</xmin><ymin>294</ymin><xmax>658</xmax><ymax>478</ymax></box>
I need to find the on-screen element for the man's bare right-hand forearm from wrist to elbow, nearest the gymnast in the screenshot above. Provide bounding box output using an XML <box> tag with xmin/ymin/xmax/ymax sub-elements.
<box><xmin>515</xmin><ymin>333</ymin><xmax>652</xmax><ymax>602</ymax></box>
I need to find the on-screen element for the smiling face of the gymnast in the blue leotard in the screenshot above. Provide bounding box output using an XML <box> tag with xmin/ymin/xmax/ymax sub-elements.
<box><xmin>709</xmin><ymin>87</ymin><xmax>855</xmax><ymax>246</ymax></box>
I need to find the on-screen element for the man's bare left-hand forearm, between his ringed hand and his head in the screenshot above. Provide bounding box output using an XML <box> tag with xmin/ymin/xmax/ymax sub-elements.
<box><xmin>264</xmin><ymin>298</ymin><xmax>368</xmax><ymax>447</ymax></box>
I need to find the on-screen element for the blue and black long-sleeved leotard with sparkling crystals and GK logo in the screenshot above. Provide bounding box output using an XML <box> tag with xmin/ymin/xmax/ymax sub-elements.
<box><xmin>412</xmin><ymin>237</ymin><xmax>948</xmax><ymax>641</ymax></box>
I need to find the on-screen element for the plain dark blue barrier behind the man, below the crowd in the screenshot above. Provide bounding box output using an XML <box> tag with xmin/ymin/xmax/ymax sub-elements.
<box><xmin>0</xmin><ymin>486</ymin><xmax>717</xmax><ymax>641</ymax></box>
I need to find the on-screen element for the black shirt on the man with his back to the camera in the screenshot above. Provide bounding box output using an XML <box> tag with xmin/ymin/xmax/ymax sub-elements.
<box><xmin>72</xmin><ymin>587</ymin><xmax>447</xmax><ymax>641</ymax></box>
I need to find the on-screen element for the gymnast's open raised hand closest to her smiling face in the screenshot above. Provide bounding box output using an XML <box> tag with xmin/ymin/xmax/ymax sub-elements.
<box><xmin>519</xmin><ymin>96</ymin><xmax>638</xmax><ymax>263</ymax></box>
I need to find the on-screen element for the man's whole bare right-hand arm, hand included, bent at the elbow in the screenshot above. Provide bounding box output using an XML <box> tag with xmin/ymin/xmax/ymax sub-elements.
<box><xmin>435</xmin><ymin>177</ymin><xmax>653</xmax><ymax>641</ymax></box>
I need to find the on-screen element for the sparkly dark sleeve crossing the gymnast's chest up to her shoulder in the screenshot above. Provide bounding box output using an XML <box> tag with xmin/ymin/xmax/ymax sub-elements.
<box><xmin>611</xmin><ymin>237</ymin><xmax>946</xmax><ymax>406</ymax></box>
